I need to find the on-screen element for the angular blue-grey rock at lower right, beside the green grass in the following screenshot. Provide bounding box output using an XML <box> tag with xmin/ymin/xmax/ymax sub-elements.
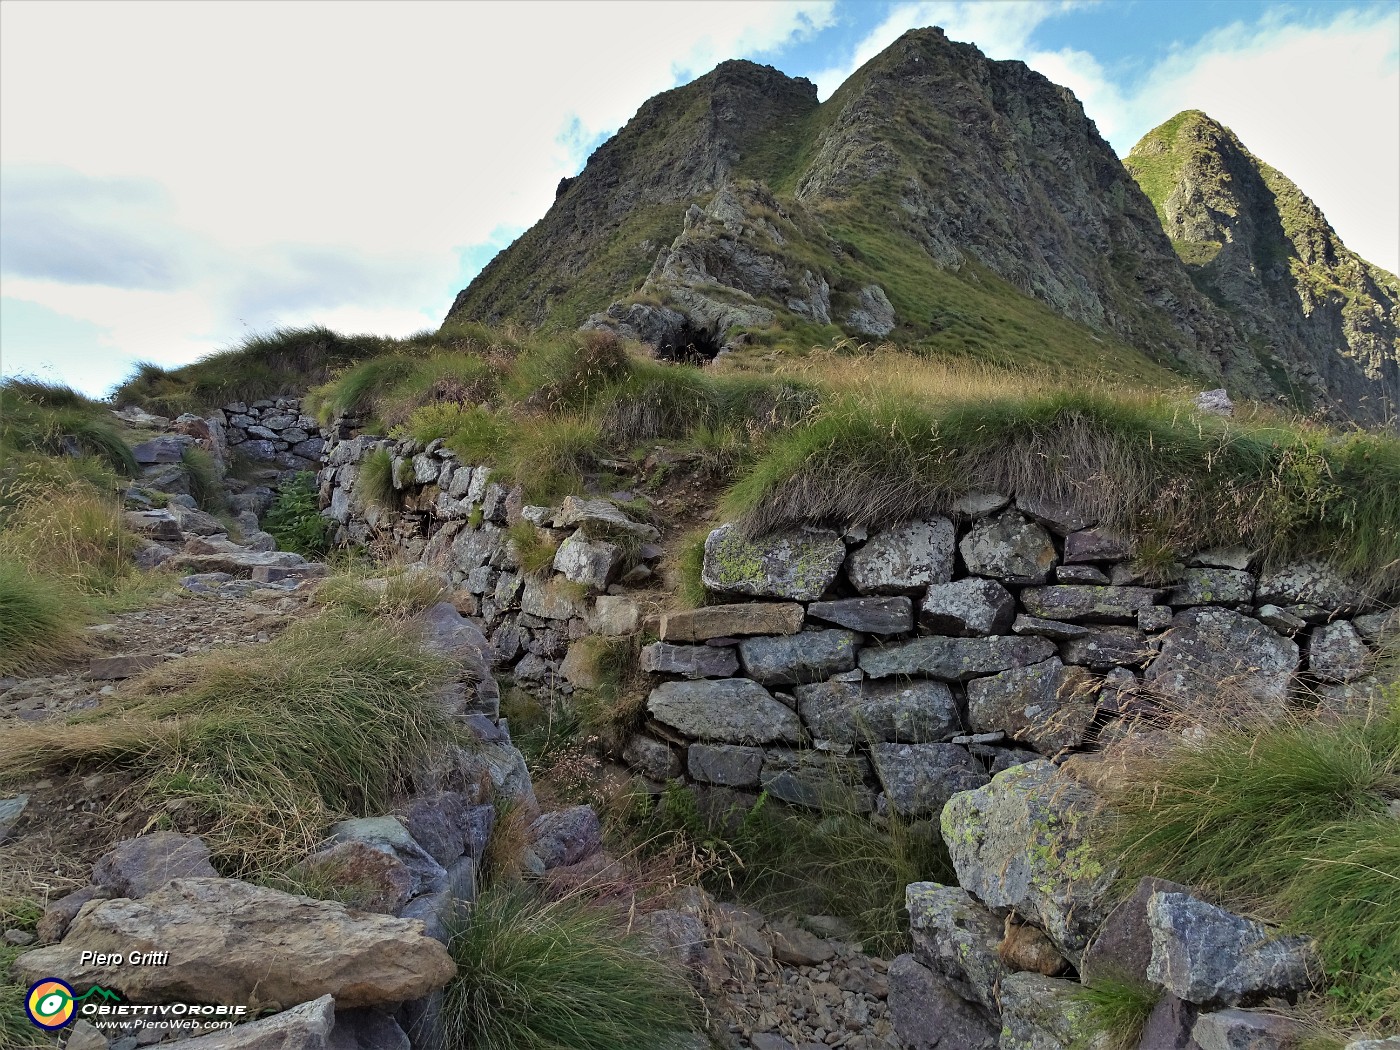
<box><xmin>1147</xmin><ymin>893</ymin><xmax>1317</xmax><ymax>1007</ymax></box>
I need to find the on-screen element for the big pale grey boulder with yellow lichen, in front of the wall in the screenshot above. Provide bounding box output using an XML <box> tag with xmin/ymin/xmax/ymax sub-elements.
<box><xmin>941</xmin><ymin>762</ymin><xmax>1113</xmax><ymax>965</ymax></box>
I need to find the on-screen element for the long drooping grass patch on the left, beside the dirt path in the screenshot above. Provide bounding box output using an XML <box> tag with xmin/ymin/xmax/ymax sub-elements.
<box><xmin>0</xmin><ymin>613</ymin><xmax>463</xmax><ymax>876</ymax></box>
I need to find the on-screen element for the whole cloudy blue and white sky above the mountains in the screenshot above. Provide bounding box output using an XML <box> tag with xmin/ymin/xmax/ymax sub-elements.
<box><xmin>0</xmin><ymin>0</ymin><xmax>1400</xmax><ymax>395</ymax></box>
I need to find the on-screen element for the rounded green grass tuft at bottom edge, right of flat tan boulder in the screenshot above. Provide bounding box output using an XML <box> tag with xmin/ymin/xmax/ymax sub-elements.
<box><xmin>440</xmin><ymin>886</ymin><xmax>699</xmax><ymax>1050</ymax></box>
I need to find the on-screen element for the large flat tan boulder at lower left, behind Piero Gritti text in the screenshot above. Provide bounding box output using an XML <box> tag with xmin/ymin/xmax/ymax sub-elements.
<box><xmin>15</xmin><ymin>878</ymin><xmax>456</xmax><ymax>1008</ymax></box>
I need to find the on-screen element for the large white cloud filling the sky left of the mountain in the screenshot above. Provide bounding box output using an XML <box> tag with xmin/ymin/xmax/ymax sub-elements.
<box><xmin>0</xmin><ymin>0</ymin><xmax>833</xmax><ymax>392</ymax></box>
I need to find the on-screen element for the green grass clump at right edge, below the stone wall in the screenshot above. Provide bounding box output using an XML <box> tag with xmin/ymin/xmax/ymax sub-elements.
<box><xmin>1103</xmin><ymin>700</ymin><xmax>1400</xmax><ymax>1025</ymax></box>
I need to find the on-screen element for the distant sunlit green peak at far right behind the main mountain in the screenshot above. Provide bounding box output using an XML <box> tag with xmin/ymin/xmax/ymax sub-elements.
<box><xmin>1126</xmin><ymin>111</ymin><xmax>1400</xmax><ymax>420</ymax></box>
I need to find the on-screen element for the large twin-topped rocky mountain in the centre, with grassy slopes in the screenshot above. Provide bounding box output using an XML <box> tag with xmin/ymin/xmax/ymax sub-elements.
<box><xmin>447</xmin><ymin>28</ymin><xmax>1394</xmax><ymax>419</ymax></box>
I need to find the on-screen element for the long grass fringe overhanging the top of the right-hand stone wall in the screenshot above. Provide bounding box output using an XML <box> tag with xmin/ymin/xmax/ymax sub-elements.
<box><xmin>722</xmin><ymin>391</ymin><xmax>1400</xmax><ymax>592</ymax></box>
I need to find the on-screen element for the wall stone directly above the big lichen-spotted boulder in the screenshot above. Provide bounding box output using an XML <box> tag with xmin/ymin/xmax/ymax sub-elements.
<box><xmin>967</xmin><ymin>657</ymin><xmax>1095</xmax><ymax>755</ymax></box>
